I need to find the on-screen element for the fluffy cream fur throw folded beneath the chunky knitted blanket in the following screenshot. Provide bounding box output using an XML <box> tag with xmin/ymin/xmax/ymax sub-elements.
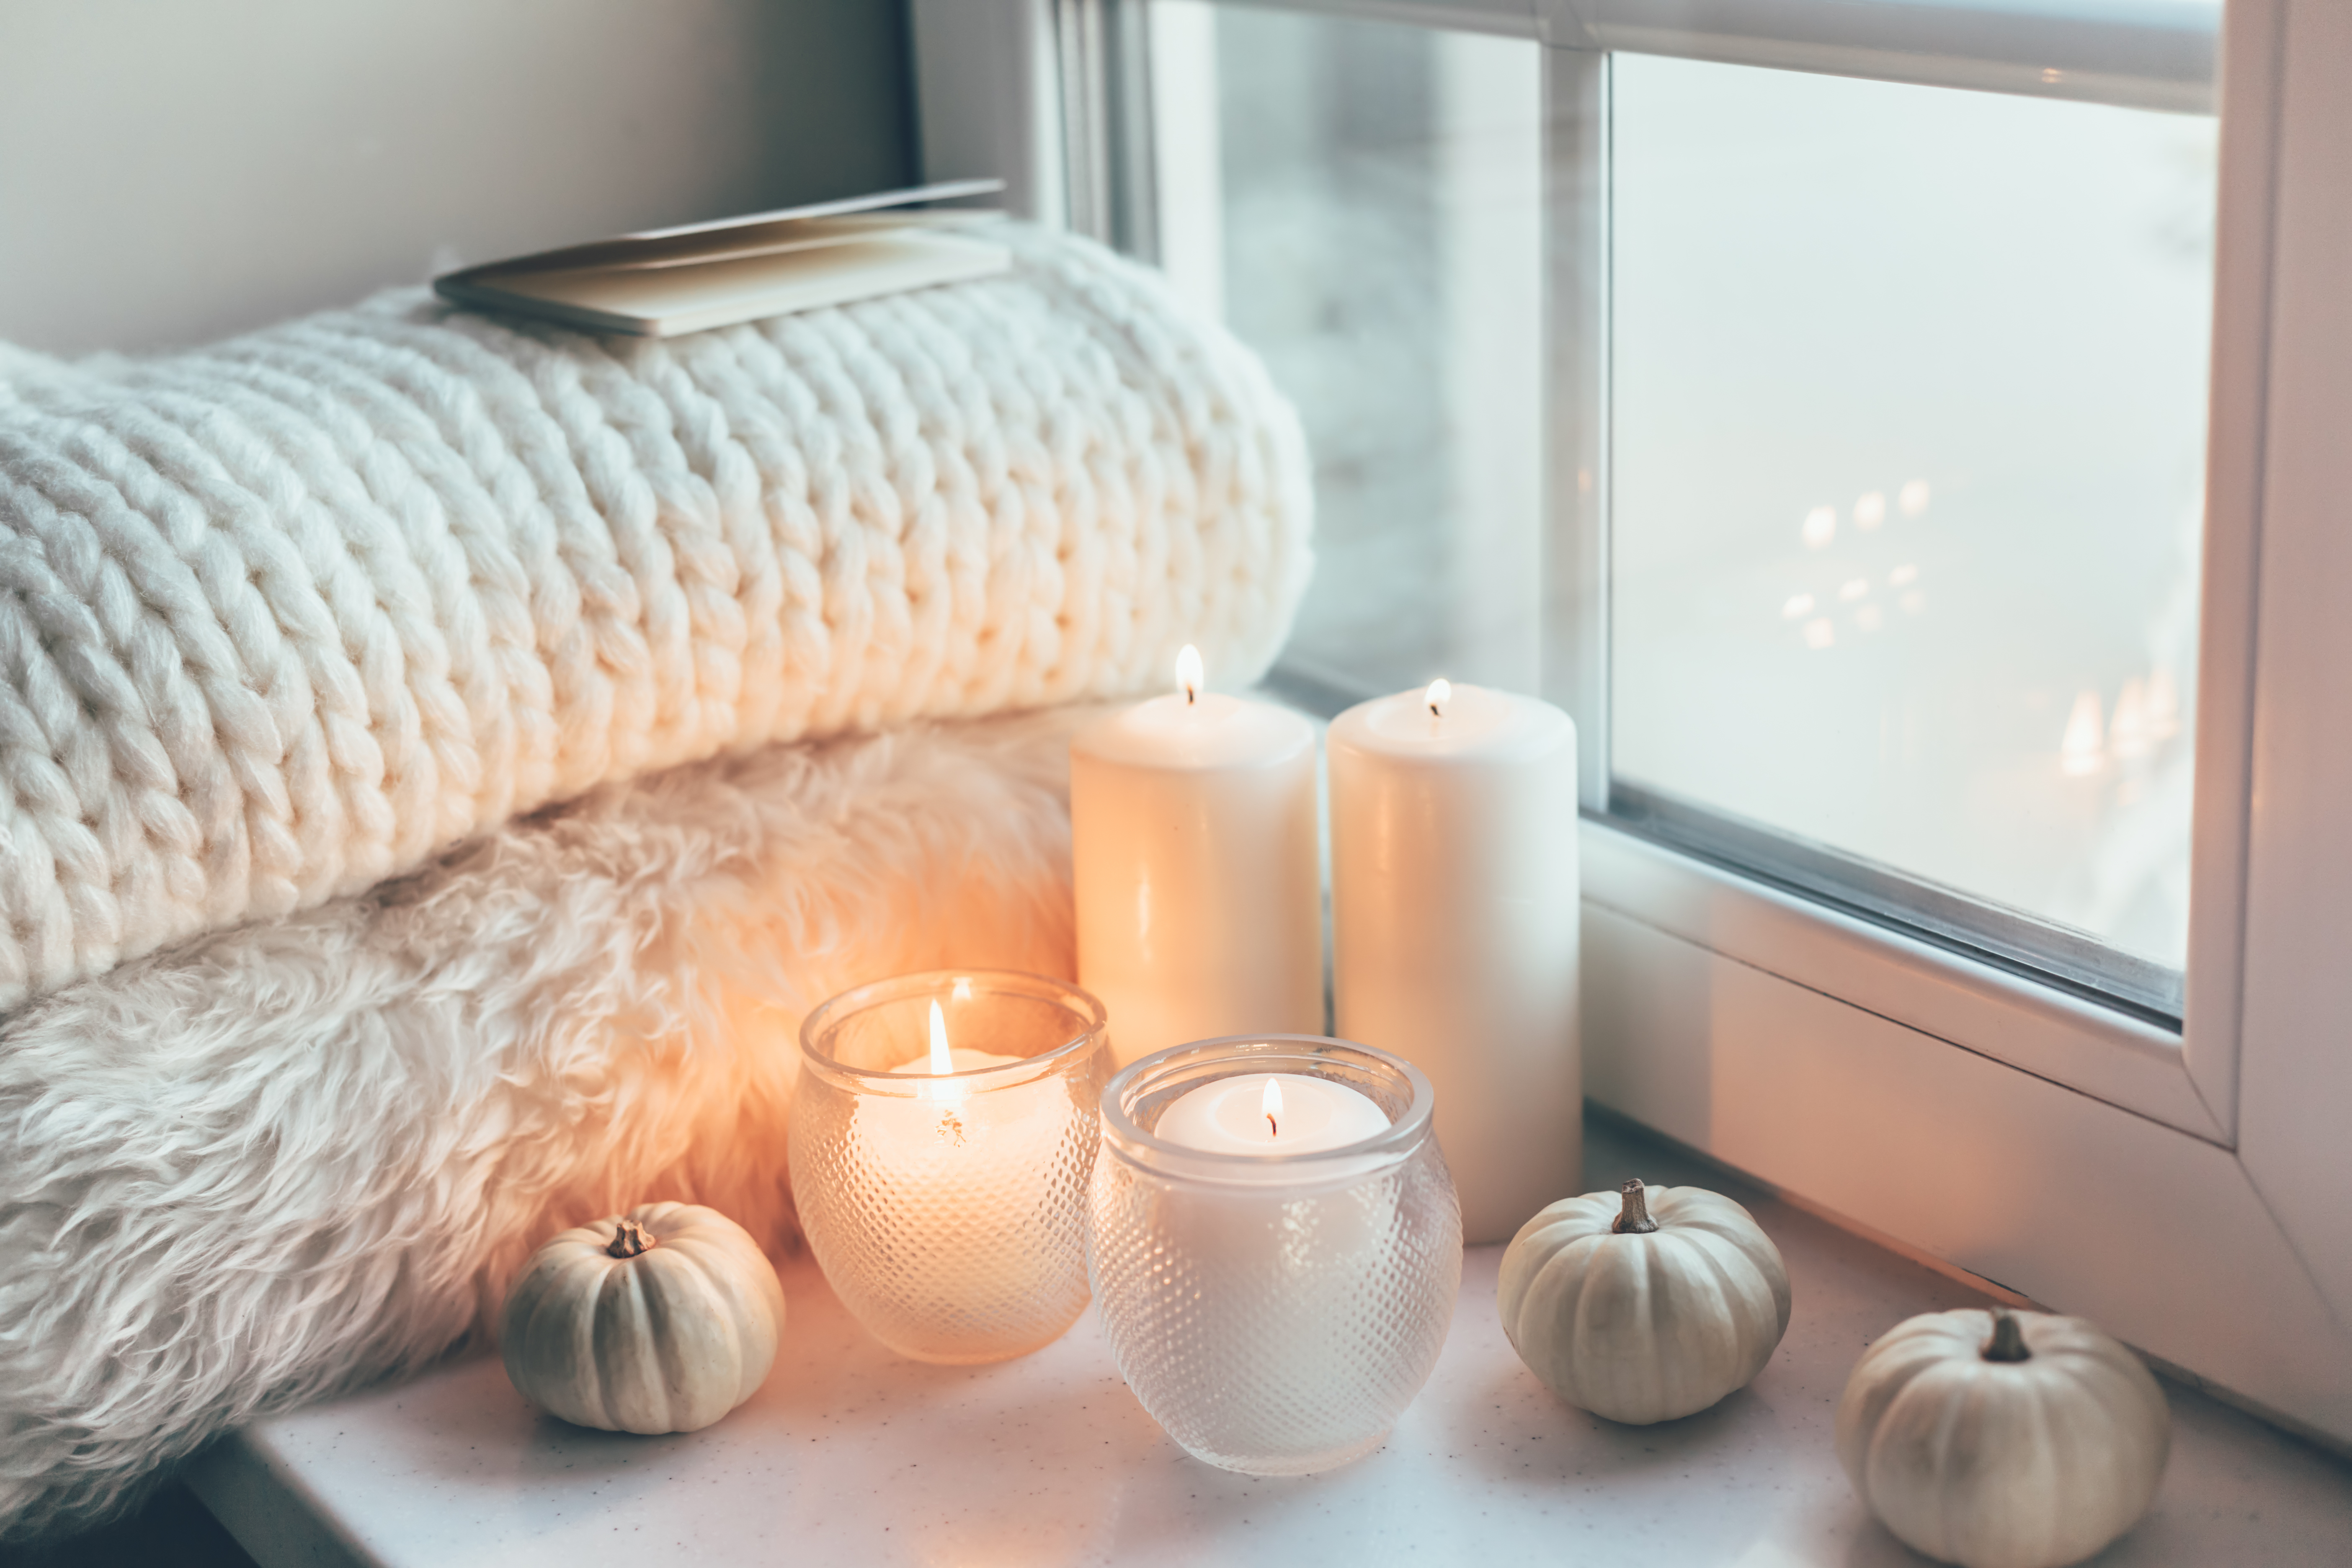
<box><xmin>0</xmin><ymin>710</ymin><xmax>1073</xmax><ymax>1535</ymax></box>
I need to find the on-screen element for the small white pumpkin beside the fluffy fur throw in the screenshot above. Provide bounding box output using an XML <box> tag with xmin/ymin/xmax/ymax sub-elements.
<box><xmin>499</xmin><ymin>1204</ymin><xmax>783</xmax><ymax>1431</ymax></box>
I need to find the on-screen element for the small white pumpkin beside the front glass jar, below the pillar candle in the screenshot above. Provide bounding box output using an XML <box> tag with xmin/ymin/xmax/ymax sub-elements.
<box><xmin>1496</xmin><ymin>1180</ymin><xmax>1790</xmax><ymax>1427</ymax></box>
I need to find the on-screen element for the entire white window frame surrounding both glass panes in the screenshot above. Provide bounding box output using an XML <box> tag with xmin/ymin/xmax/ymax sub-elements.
<box><xmin>913</xmin><ymin>0</ymin><xmax>2352</xmax><ymax>1444</ymax></box>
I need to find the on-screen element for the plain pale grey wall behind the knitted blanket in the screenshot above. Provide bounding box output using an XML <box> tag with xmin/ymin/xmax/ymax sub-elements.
<box><xmin>0</xmin><ymin>0</ymin><xmax>913</xmax><ymax>350</ymax></box>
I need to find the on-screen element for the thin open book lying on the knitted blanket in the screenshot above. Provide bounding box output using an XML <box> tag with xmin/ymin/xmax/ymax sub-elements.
<box><xmin>433</xmin><ymin>179</ymin><xmax>1011</xmax><ymax>338</ymax></box>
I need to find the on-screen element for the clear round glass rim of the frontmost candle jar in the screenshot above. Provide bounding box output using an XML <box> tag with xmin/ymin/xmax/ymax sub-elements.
<box><xmin>1103</xmin><ymin>1034</ymin><xmax>1437</xmax><ymax>1182</ymax></box>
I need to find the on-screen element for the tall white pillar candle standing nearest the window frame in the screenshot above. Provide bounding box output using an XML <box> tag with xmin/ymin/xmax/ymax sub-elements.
<box><xmin>1329</xmin><ymin>682</ymin><xmax>1583</xmax><ymax>1243</ymax></box>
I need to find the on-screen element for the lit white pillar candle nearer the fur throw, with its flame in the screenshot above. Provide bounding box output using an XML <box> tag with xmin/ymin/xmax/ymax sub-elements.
<box><xmin>1070</xmin><ymin>647</ymin><xmax>1322</xmax><ymax>1067</ymax></box>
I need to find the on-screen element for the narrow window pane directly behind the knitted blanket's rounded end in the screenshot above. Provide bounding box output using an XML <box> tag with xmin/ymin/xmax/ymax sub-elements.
<box><xmin>1150</xmin><ymin>0</ymin><xmax>1543</xmax><ymax>696</ymax></box>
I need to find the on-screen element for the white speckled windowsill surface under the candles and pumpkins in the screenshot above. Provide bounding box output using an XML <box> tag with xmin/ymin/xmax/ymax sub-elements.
<box><xmin>191</xmin><ymin>1121</ymin><xmax>2352</xmax><ymax>1568</ymax></box>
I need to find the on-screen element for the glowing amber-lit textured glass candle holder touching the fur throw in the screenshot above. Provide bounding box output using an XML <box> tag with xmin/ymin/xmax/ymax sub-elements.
<box><xmin>790</xmin><ymin>971</ymin><xmax>1110</xmax><ymax>1364</ymax></box>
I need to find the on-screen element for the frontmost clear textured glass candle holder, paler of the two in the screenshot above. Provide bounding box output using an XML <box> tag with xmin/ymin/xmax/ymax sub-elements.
<box><xmin>1087</xmin><ymin>1034</ymin><xmax>1463</xmax><ymax>1476</ymax></box>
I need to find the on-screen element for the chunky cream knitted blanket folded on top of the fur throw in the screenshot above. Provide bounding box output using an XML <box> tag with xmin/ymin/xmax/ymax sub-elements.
<box><xmin>0</xmin><ymin>230</ymin><xmax>1310</xmax><ymax>1020</ymax></box>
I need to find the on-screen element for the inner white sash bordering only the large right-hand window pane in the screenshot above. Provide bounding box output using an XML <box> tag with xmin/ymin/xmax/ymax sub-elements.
<box><xmin>1538</xmin><ymin>0</ymin><xmax>2239</xmax><ymax>1128</ymax></box>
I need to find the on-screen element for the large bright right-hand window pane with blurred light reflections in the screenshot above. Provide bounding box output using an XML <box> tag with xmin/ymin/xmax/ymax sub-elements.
<box><xmin>1611</xmin><ymin>54</ymin><xmax>2215</xmax><ymax>983</ymax></box>
